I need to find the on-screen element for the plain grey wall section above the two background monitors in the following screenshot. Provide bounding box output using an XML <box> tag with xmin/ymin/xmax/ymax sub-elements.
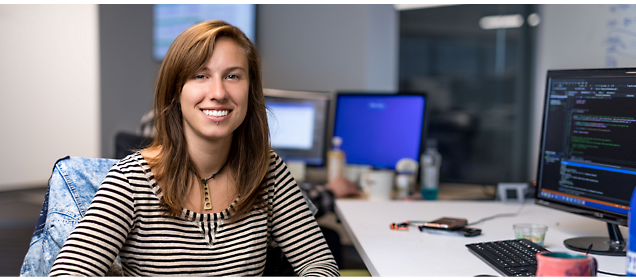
<box><xmin>256</xmin><ymin>5</ymin><xmax>399</xmax><ymax>91</ymax></box>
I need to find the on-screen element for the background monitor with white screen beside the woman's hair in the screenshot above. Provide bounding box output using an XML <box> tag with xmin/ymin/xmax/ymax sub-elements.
<box><xmin>264</xmin><ymin>89</ymin><xmax>332</xmax><ymax>166</ymax></box>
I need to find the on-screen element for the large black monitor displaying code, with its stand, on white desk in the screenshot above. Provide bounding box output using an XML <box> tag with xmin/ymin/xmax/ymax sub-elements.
<box><xmin>535</xmin><ymin>68</ymin><xmax>636</xmax><ymax>255</ymax></box>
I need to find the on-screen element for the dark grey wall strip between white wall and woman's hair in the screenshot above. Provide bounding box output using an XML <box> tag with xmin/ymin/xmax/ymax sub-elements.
<box><xmin>99</xmin><ymin>5</ymin><xmax>161</xmax><ymax>158</ymax></box>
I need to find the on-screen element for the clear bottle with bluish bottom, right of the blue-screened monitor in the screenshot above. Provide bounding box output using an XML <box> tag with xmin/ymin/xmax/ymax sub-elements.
<box><xmin>420</xmin><ymin>139</ymin><xmax>442</xmax><ymax>200</ymax></box>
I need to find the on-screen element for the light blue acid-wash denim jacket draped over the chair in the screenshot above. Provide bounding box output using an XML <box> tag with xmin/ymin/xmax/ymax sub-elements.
<box><xmin>20</xmin><ymin>156</ymin><xmax>317</xmax><ymax>277</ymax></box>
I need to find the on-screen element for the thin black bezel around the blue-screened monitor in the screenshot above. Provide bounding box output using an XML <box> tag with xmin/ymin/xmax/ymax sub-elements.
<box><xmin>329</xmin><ymin>91</ymin><xmax>429</xmax><ymax>171</ymax></box>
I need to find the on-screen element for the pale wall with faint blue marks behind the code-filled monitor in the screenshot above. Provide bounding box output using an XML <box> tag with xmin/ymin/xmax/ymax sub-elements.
<box><xmin>530</xmin><ymin>5</ymin><xmax>636</xmax><ymax>177</ymax></box>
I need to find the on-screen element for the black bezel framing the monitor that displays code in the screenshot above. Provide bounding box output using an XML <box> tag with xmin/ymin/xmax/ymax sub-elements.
<box><xmin>535</xmin><ymin>68</ymin><xmax>636</xmax><ymax>226</ymax></box>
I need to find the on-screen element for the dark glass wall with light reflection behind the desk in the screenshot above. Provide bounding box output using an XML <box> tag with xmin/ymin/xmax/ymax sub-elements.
<box><xmin>399</xmin><ymin>5</ymin><xmax>539</xmax><ymax>184</ymax></box>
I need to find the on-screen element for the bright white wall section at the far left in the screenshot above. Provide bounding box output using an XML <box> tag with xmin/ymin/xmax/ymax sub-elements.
<box><xmin>0</xmin><ymin>5</ymin><xmax>100</xmax><ymax>190</ymax></box>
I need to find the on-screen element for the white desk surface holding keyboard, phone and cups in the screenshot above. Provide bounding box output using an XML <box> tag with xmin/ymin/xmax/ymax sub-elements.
<box><xmin>336</xmin><ymin>199</ymin><xmax>627</xmax><ymax>277</ymax></box>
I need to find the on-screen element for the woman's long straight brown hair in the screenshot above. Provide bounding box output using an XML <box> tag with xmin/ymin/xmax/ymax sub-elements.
<box><xmin>146</xmin><ymin>20</ymin><xmax>270</xmax><ymax>222</ymax></box>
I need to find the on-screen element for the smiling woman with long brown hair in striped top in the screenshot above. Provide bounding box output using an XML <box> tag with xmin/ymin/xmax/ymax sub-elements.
<box><xmin>50</xmin><ymin>21</ymin><xmax>339</xmax><ymax>276</ymax></box>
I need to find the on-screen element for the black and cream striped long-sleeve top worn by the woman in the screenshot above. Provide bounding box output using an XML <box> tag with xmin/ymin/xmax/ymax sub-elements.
<box><xmin>49</xmin><ymin>152</ymin><xmax>339</xmax><ymax>276</ymax></box>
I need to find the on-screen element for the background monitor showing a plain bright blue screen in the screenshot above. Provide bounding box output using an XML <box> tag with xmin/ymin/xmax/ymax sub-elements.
<box><xmin>333</xmin><ymin>93</ymin><xmax>426</xmax><ymax>169</ymax></box>
